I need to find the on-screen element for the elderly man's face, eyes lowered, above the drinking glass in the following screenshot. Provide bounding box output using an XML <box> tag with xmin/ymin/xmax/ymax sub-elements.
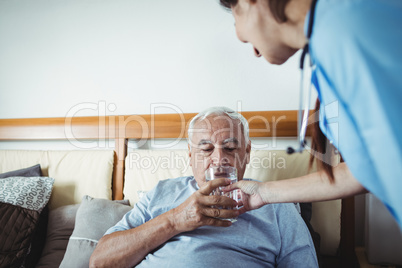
<box><xmin>189</xmin><ymin>115</ymin><xmax>251</xmax><ymax>187</ymax></box>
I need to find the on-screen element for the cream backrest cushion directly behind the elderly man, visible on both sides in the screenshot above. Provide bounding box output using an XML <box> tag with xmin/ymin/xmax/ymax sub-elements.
<box><xmin>123</xmin><ymin>150</ymin><xmax>341</xmax><ymax>256</ymax></box>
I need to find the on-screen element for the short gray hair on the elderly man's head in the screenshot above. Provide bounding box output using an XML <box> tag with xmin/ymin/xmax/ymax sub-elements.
<box><xmin>188</xmin><ymin>107</ymin><xmax>249</xmax><ymax>144</ymax></box>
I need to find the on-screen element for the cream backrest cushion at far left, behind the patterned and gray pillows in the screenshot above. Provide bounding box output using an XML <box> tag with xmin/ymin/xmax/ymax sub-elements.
<box><xmin>0</xmin><ymin>150</ymin><xmax>114</xmax><ymax>209</ymax></box>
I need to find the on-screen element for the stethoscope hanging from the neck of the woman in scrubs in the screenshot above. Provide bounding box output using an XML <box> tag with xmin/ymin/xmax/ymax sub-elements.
<box><xmin>286</xmin><ymin>0</ymin><xmax>317</xmax><ymax>154</ymax></box>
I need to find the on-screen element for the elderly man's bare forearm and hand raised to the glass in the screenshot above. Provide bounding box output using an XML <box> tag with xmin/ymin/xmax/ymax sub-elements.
<box><xmin>90</xmin><ymin>179</ymin><xmax>238</xmax><ymax>267</ymax></box>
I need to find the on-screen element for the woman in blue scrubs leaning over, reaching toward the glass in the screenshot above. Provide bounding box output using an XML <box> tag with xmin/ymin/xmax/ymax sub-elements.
<box><xmin>220</xmin><ymin>0</ymin><xmax>402</xmax><ymax>228</ymax></box>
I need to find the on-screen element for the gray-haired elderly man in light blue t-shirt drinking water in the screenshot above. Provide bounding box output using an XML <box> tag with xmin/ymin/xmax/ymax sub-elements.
<box><xmin>90</xmin><ymin>107</ymin><xmax>318</xmax><ymax>267</ymax></box>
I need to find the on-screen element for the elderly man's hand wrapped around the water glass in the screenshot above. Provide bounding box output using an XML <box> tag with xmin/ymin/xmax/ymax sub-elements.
<box><xmin>170</xmin><ymin>179</ymin><xmax>239</xmax><ymax>232</ymax></box>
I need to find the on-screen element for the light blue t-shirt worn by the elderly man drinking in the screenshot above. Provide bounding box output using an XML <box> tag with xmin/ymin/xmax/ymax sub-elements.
<box><xmin>106</xmin><ymin>177</ymin><xmax>318</xmax><ymax>268</ymax></box>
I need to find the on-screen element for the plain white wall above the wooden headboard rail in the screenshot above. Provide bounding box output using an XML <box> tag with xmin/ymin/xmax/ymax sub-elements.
<box><xmin>0</xmin><ymin>0</ymin><xmax>312</xmax><ymax>118</ymax></box>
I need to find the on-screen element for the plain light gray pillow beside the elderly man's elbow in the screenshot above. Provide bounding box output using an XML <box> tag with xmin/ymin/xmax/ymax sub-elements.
<box><xmin>60</xmin><ymin>195</ymin><xmax>131</xmax><ymax>268</ymax></box>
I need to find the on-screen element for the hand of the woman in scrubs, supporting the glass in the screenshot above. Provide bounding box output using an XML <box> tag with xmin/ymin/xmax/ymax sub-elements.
<box><xmin>223</xmin><ymin>180</ymin><xmax>268</xmax><ymax>214</ymax></box>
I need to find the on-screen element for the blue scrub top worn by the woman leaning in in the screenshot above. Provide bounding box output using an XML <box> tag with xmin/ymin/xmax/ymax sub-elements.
<box><xmin>305</xmin><ymin>0</ymin><xmax>402</xmax><ymax>228</ymax></box>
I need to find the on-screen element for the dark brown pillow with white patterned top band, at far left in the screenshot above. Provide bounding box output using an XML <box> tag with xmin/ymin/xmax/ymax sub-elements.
<box><xmin>0</xmin><ymin>177</ymin><xmax>54</xmax><ymax>267</ymax></box>
